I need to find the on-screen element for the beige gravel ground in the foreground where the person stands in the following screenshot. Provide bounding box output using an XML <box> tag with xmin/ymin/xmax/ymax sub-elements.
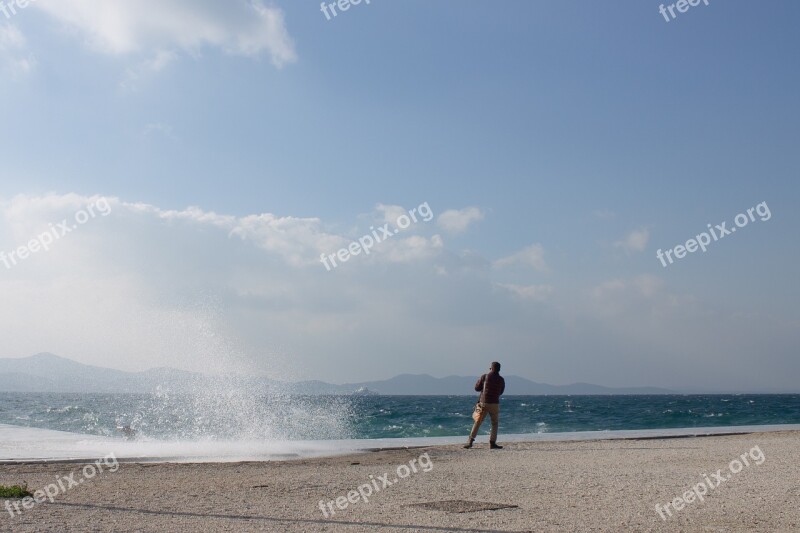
<box><xmin>0</xmin><ymin>432</ymin><xmax>800</xmax><ymax>532</ymax></box>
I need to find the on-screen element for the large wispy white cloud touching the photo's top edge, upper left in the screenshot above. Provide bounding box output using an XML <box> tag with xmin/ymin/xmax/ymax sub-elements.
<box><xmin>32</xmin><ymin>0</ymin><xmax>296</xmax><ymax>69</ymax></box>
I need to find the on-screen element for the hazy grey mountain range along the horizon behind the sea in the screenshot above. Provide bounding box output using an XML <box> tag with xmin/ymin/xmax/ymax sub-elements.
<box><xmin>0</xmin><ymin>353</ymin><xmax>674</xmax><ymax>396</ymax></box>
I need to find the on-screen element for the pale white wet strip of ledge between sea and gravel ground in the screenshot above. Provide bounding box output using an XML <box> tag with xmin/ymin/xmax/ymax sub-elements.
<box><xmin>0</xmin><ymin>424</ymin><xmax>800</xmax><ymax>462</ymax></box>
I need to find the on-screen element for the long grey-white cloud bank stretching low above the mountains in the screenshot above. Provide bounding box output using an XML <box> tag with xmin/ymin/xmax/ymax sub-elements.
<box><xmin>0</xmin><ymin>194</ymin><xmax>797</xmax><ymax>388</ymax></box>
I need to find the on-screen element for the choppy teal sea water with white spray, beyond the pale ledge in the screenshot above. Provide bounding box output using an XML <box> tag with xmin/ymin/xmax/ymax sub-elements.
<box><xmin>0</xmin><ymin>391</ymin><xmax>800</xmax><ymax>438</ymax></box>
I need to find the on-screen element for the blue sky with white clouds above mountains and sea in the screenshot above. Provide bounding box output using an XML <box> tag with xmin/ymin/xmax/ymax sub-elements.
<box><xmin>0</xmin><ymin>0</ymin><xmax>800</xmax><ymax>392</ymax></box>
